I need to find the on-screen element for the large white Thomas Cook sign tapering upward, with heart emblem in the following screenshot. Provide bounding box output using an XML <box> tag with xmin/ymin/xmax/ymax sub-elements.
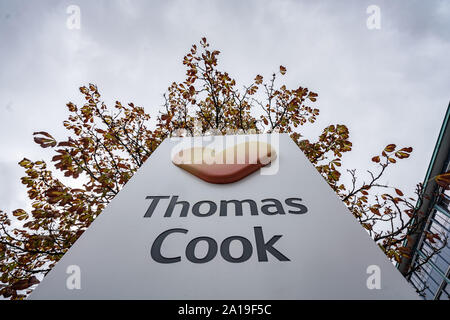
<box><xmin>31</xmin><ymin>135</ymin><xmax>416</xmax><ymax>299</ymax></box>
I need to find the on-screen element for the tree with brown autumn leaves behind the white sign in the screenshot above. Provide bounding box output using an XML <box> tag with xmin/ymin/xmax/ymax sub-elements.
<box><xmin>0</xmin><ymin>38</ymin><xmax>446</xmax><ymax>299</ymax></box>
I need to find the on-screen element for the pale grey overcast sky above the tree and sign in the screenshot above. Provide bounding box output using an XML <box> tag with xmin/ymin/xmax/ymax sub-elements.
<box><xmin>0</xmin><ymin>0</ymin><xmax>450</xmax><ymax>215</ymax></box>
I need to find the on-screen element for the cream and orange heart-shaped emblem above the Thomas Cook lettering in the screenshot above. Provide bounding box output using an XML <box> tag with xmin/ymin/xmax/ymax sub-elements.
<box><xmin>172</xmin><ymin>141</ymin><xmax>277</xmax><ymax>184</ymax></box>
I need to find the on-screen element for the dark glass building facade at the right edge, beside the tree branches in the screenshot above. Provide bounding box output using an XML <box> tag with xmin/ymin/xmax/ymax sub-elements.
<box><xmin>398</xmin><ymin>105</ymin><xmax>450</xmax><ymax>300</ymax></box>
